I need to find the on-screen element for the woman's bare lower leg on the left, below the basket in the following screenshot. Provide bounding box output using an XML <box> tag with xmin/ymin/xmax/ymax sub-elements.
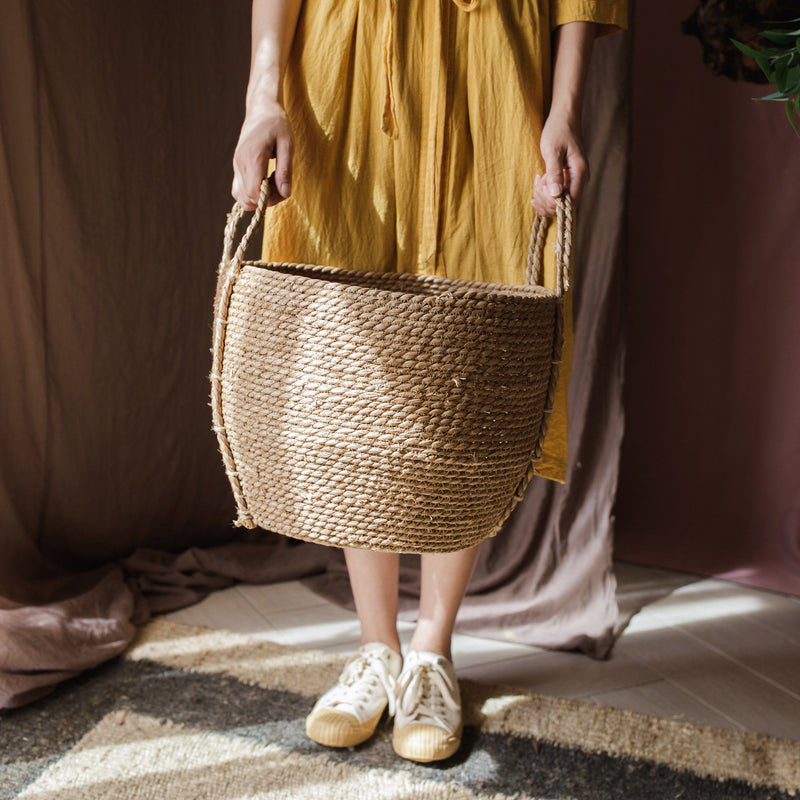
<box><xmin>344</xmin><ymin>547</ymin><xmax>400</xmax><ymax>653</ymax></box>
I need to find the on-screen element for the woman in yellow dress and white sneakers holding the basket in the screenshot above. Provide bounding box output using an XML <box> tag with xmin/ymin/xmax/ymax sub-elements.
<box><xmin>232</xmin><ymin>0</ymin><xmax>625</xmax><ymax>762</ymax></box>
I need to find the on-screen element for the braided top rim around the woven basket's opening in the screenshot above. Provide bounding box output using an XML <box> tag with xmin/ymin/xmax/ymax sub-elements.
<box><xmin>242</xmin><ymin>260</ymin><xmax>562</xmax><ymax>305</ymax></box>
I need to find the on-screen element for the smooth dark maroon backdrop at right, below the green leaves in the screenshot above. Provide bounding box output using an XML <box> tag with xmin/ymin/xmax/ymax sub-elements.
<box><xmin>616</xmin><ymin>0</ymin><xmax>800</xmax><ymax>595</ymax></box>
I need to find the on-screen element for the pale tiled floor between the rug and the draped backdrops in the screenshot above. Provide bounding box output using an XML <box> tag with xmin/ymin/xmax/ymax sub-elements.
<box><xmin>162</xmin><ymin>564</ymin><xmax>800</xmax><ymax>744</ymax></box>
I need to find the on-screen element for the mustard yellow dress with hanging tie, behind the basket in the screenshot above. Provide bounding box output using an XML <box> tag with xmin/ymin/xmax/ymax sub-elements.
<box><xmin>262</xmin><ymin>0</ymin><xmax>626</xmax><ymax>482</ymax></box>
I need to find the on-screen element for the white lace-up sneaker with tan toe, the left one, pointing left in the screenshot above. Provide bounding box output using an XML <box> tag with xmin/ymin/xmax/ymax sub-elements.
<box><xmin>306</xmin><ymin>642</ymin><xmax>403</xmax><ymax>747</ymax></box>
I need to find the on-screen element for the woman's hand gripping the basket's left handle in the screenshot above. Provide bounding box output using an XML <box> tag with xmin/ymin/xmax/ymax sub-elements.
<box><xmin>231</xmin><ymin>102</ymin><xmax>294</xmax><ymax>211</ymax></box>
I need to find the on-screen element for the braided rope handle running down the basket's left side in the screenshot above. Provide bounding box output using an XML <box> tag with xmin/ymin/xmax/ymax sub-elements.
<box><xmin>209</xmin><ymin>178</ymin><xmax>269</xmax><ymax>528</ymax></box>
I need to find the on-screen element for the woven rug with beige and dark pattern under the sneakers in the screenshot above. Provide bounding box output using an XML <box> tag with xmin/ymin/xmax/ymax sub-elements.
<box><xmin>0</xmin><ymin>620</ymin><xmax>800</xmax><ymax>800</ymax></box>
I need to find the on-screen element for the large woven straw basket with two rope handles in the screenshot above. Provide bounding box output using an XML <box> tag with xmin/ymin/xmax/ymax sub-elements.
<box><xmin>210</xmin><ymin>181</ymin><xmax>572</xmax><ymax>553</ymax></box>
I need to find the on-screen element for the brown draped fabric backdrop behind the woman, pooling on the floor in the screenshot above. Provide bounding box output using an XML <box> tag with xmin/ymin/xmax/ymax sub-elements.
<box><xmin>0</xmin><ymin>0</ymin><xmax>629</xmax><ymax>706</ymax></box>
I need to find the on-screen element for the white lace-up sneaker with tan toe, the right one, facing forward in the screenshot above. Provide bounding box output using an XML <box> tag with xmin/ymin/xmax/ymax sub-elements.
<box><xmin>392</xmin><ymin>650</ymin><xmax>462</xmax><ymax>762</ymax></box>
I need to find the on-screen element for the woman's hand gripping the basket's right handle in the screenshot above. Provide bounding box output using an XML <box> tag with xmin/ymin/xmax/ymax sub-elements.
<box><xmin>531</xmin><ymin>112</ymin><xmax>589</xmax><ymax>217</ymax></box>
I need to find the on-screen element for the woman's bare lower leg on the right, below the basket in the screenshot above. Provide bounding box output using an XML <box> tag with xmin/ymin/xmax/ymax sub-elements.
<box><xmin>408</xmin><ymin>544</ymin><xmax>481</xmax><ymax>659</ymax></box>
